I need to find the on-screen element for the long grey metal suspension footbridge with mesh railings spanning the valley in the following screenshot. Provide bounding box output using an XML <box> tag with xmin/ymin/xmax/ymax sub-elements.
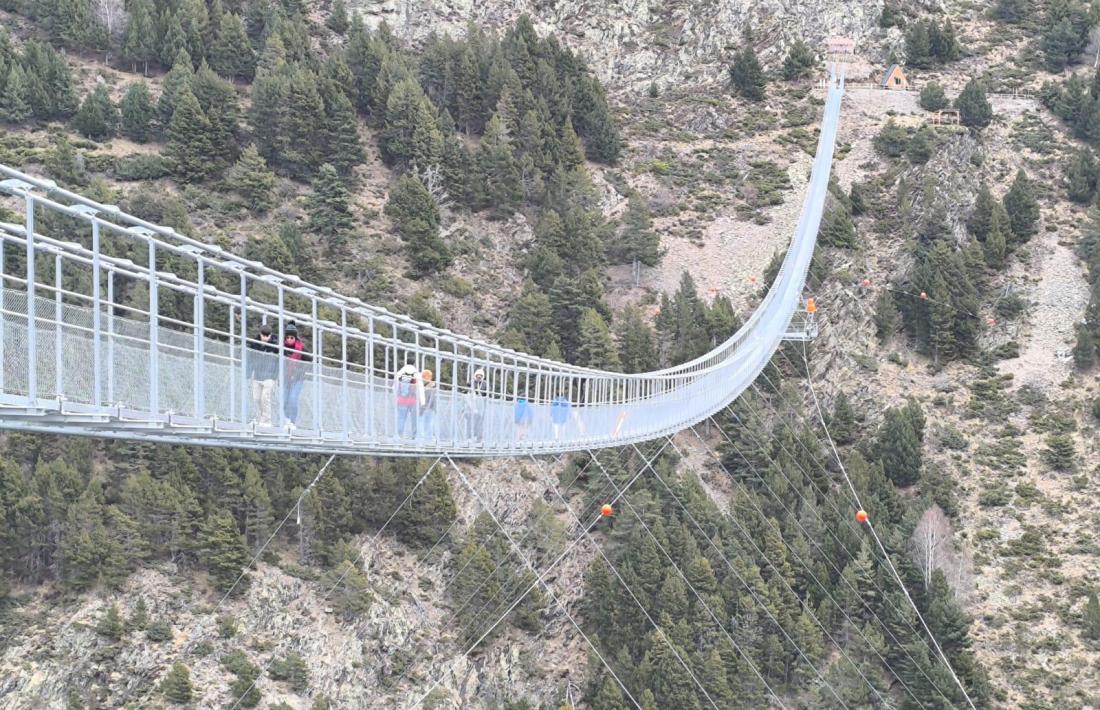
<box><xmin>0</xmin><ymin>77</ymin><xmax>844</xmax><ymax>457</ymax></box>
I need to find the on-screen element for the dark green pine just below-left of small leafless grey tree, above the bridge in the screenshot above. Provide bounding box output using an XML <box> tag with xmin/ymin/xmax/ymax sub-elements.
<box><xmin>384</xmin><ymin>175</ymin><xmax>451</xmax><ymax>274</ymax></box>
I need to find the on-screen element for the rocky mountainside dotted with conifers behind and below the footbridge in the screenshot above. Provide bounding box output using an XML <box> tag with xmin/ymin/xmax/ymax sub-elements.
<box><xmin>0</xmin><ymin>0</ymin><xmax>1100</xmax><ymax>710</ymax></box>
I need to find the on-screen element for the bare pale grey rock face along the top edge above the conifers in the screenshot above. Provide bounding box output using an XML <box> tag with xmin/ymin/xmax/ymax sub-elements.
<box><xmin>349</xmin><ymin>0</ymin><xmax>941</xmax><ymax>90</ymax></box>
